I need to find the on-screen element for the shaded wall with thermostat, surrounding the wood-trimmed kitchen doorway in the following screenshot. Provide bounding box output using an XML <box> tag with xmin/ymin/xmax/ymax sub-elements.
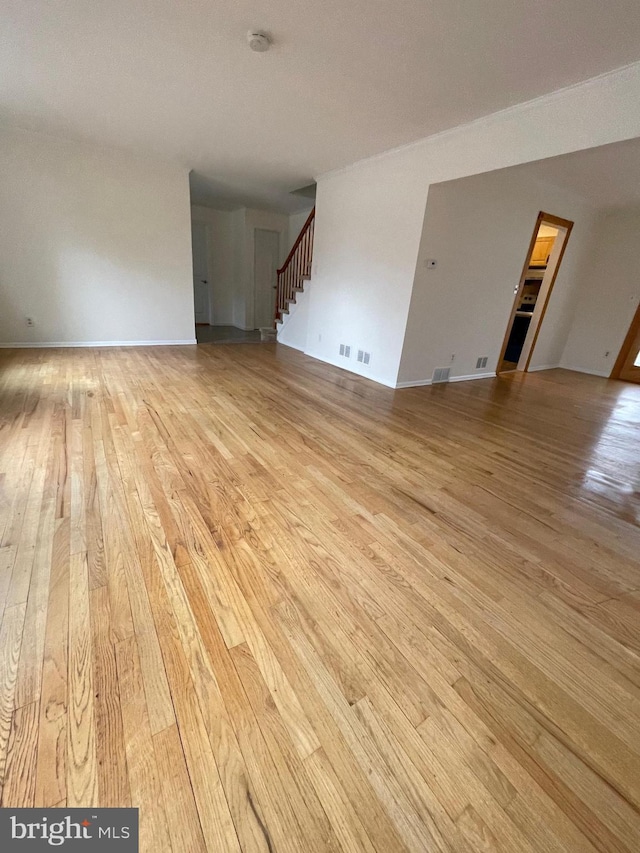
<box><xmin>398</xmin><ymin>167</ymin><xmax>595</xmax><ymax>383</ymax></box>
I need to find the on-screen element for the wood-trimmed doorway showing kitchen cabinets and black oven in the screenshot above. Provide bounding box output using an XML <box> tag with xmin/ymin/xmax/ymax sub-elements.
<box><xmin>496</xmin><ymin>211</ymin><xmax>573</xmax><ymax>373</ymax></box>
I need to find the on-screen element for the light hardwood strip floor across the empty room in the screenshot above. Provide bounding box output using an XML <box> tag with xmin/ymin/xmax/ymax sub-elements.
<box><xmin>0</xmin><ymin>345</ymin><xmax>640</xmax><ymax>853</ymax></box>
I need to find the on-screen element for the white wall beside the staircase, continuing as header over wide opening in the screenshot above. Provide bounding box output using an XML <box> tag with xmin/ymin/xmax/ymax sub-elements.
<box><xmin>306</xmin><ymin>56</ymin><xmax>640</xmax><ymax>385</ymax></box>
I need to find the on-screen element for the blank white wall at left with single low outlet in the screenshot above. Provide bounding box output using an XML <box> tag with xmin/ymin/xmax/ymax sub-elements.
<box><xmin>0</xmin><ymin>125</ymin><xmax>194</xmax><ymax>344</ymax></box>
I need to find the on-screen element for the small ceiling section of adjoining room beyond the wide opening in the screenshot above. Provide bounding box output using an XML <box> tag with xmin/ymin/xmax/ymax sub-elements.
<box><xmin>502</xmin><ymin>139</ymin><xmax>640</xmax><ymax>210</ymax></box>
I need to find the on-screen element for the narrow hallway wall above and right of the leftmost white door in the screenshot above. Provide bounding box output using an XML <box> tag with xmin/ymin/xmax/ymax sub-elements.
<box><xmin>191</xmin><ymin>205</ymin><xmax>235</xmax><ymax>326</ymax></box>
